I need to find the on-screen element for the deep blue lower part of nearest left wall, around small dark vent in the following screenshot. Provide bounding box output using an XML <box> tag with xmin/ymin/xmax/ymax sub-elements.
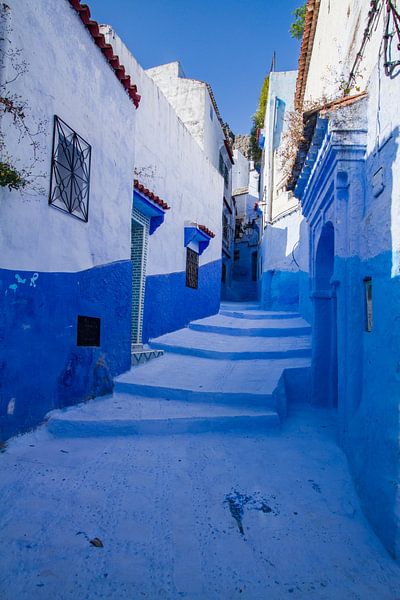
<box><xmin>0</xmin><ymin>261</ymin><xmax>132</xmax><ymax>439</ymax></box>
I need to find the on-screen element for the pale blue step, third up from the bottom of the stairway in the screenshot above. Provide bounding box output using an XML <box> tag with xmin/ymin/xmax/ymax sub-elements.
<box><xmin>149</xmin><ymin>328</ymin><xmax>311</xmax><ymax>361</ymax></box>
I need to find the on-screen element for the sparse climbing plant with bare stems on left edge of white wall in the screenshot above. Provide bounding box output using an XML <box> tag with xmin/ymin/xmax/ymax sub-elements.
<box><xmin>0</xmin><ymin>3</ymin><xmax>46</xmax><ymax>193</ymax></box>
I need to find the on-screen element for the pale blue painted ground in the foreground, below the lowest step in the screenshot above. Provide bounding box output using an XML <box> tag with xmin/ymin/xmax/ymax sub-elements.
<box><xmin>0</xmin><ymin>407</ymin><xmax>400</xmax><ymax>600</ymax></box>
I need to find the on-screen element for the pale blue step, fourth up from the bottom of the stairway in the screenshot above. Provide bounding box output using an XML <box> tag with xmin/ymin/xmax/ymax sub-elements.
<box><xmin>189</xmin><ymin>314</ymin><xmax>311</xmax><ymax>337</ymax></box>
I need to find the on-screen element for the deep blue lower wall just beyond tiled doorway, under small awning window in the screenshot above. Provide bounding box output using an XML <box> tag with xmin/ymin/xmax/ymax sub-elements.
<box><xmin>143</xmin><ymin>260</ymin><xmax>222</xmax><ymax>342</ymax></box>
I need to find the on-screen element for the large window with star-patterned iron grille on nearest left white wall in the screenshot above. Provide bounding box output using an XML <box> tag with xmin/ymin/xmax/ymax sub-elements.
<box><xmin>49</xmin><ymin>115</ymin><xmax>92</xmax><ymax>222</ymax></box>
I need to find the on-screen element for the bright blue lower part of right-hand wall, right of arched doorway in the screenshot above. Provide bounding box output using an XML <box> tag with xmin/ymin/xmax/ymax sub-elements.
<box><xmin>335</xmin><ymin>252</ymin><xmax>400</xmax><ymax>558</ymax></box>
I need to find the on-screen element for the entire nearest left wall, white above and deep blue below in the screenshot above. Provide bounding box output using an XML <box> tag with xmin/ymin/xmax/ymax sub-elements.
<box><xmin>0</xmin><ymin>0</ymin><xmax>136</xmax><ymax>438</ymax></box>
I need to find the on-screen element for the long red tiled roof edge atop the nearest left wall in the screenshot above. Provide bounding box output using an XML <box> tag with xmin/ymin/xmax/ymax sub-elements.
<box><xmin>68</xmin><ymin>0</ymin><xmax>140</xmax><ymax>108</ymax></box>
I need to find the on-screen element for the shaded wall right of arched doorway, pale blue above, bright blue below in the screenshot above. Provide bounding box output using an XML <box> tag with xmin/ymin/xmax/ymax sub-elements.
<box><xmin>335</xmin><ymin>128</ymin><xmax>400</xmax><ymax>558</ymax></box>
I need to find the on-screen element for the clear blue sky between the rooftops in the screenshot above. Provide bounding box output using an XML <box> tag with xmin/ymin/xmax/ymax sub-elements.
<box><xmin>88</xmin><ymin>0</ymin><xmax>302</xmax><ymax>133</ymax></box>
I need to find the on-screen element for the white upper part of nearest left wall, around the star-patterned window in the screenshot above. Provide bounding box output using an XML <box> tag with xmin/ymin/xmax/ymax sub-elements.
<box><xmin>0</xmin><ymin>0</ymin><xmax>136</xmax><ymax>272</ymax></box>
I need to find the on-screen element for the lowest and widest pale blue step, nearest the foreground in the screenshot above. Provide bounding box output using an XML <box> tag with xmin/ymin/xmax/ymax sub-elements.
<box><xmin>47</xmin><ymin>393</ymin><xmax>280</xmax><ymax>437</ymax></box>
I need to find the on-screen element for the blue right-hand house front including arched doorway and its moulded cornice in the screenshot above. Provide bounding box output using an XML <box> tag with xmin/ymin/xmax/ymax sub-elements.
<box><xmin>296</xmin><ymin>90</ymin><xmax>400</xmax><ymax>558</ymax></box>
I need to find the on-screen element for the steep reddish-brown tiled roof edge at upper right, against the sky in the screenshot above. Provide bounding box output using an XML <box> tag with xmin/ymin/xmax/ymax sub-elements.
<box><xmin>295</xmin><ymin>0</ymin><xmax>321</xmax><ymax>110</ymax></box>
